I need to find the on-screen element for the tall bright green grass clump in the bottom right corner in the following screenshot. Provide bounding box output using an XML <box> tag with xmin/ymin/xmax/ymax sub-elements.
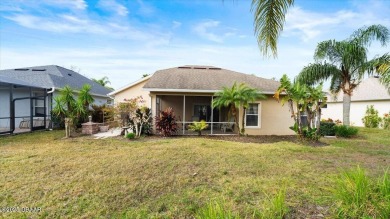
<box><xmin>333</xmin><ymin>167</ymin><xmax>390</xmax><ymax>218</ymax></box>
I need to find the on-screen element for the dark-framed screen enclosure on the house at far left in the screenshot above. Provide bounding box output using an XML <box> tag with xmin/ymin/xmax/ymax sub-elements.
<box><xmin>0</xmin><ymin>77</ymin><xmax>52</xmax><ymax>134</ymax></box>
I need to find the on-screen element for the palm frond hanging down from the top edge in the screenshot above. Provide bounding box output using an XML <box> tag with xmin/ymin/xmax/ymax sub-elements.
<box><xmin>251</xmin><ymin>0</ymin><xmax>294</xmax><ymax>57</ymax></box>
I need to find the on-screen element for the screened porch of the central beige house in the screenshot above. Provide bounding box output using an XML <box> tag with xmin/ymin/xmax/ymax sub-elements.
<box><xmin>155</xmin><ymin>95</ymin><xmax>237</xmax><ymax>135</ymax></box>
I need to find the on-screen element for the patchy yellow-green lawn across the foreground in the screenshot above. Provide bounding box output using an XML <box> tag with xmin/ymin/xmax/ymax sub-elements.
<box><xmin>0</xmin><ymin>129</ymin><xmax>390</xmax><ymax>218</ymax></box>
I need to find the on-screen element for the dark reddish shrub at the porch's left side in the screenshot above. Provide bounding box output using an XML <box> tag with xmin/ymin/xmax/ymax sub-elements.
<box><xmin>155</xmin><ymin>107</ymin><xmax>177</xmax><ymax>136</ymax></box>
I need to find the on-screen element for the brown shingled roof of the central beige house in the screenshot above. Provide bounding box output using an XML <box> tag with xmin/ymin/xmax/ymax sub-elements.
<box><xmin>144</xmin><ymin>65</ymin><xmax>279</xmax><ymax>93</ymax></box>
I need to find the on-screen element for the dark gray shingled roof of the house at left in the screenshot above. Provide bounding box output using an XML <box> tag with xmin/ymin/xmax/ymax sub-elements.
<box><xmin>0</xmin><ymin>65</ymin><xmax>111</xmax><ymax>96</ymax></box>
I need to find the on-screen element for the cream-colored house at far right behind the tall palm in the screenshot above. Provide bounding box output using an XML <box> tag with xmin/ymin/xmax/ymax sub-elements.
<box><xmin>322</xmin><ymin>77</ymin><xmax>390</xmax><ymax>126</ymax></box>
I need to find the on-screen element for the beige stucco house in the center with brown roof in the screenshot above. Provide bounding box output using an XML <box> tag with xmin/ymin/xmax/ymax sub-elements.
<box><xmin>109</xmin><ymin>66</ymin><xmax>294</xmax><ymax>135</ymax></box>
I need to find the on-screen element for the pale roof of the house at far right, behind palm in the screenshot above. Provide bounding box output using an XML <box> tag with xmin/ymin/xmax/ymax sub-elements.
<box><xmin>328</xmin><ymin>77</ymin><xmax>390</xmax><ymax>102</ymax></box>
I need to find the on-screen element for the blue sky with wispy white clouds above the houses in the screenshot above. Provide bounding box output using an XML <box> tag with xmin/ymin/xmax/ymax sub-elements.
<box><xmin>0</xmin><ymin>0</ymin><xmax>390</xmax><ymax>88</ymax></box>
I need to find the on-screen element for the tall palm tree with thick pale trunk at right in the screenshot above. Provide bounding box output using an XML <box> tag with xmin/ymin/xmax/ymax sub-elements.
<box><xmin>297</xmin><ymin>25</ymin><xmax>389</xmax><ymax>125</ymax></box>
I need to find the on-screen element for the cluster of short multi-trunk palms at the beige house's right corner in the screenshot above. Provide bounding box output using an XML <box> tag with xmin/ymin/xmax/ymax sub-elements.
<box><xmin>274</xmin><ymin>75</ymin><xmax>326</xmax><ymax>140</ymax></box>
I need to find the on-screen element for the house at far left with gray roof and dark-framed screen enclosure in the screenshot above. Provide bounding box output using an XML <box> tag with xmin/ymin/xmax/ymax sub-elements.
<box><xmin>0</xmin><ymin>65</ymin><xmax>110</xmax><ymax>133</ymax></box>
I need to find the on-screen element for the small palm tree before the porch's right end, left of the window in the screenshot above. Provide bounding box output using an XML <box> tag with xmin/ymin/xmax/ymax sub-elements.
<box><xmin>213</xmin><ymin>83</ymin><xmax>266</xmax><ymax>135</ymax></box>
